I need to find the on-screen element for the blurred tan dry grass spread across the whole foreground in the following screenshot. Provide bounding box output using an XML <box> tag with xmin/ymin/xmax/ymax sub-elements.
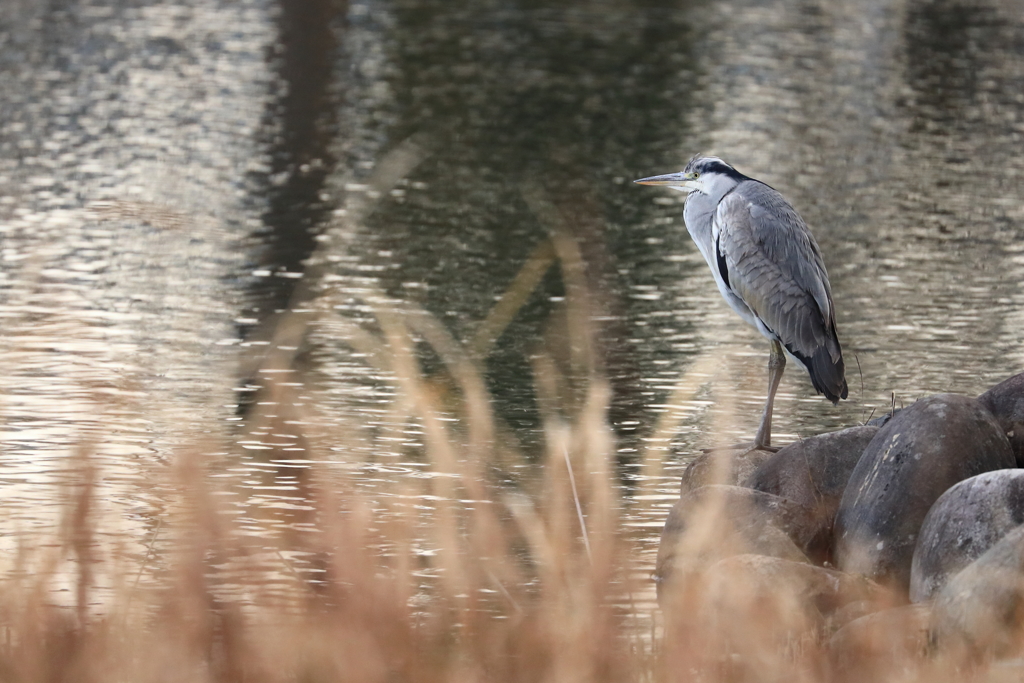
<box><xmin>0</xmin><ymin>348</ymin><xmax>983</xmax><ymax>683</ymax></box>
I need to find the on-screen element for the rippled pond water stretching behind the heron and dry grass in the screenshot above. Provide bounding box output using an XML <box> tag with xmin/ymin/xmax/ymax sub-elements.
<box><xmin>0</xmin><ymin>0</ymin><xmax>1024</xmax><ymax>618</ymax></box>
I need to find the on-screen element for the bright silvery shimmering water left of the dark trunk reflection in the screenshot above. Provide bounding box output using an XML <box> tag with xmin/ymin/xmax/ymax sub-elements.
<box><xmin>0</xmin><ymin>3</ymin><xmax>271</xmax><ymax>581</ymax></box>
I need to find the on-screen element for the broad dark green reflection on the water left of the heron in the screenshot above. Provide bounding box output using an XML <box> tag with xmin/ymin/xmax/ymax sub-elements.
<box><xmin>315</xmin><ymin>3</ymin><xmax>689</xmax><ymax>458</ymax></box>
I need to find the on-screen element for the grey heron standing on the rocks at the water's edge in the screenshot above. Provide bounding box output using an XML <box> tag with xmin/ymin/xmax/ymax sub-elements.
<box><xmin>635</xmin><ymin>156</ymin><xmax>849</xmax><ymax>450</ymax></box>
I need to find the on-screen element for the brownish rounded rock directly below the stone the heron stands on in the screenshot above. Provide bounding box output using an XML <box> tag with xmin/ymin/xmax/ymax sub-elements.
<box><xmin>654</xmin><ymin>485</ymin><xmax>809</xmax><ymax>597</ymax></box>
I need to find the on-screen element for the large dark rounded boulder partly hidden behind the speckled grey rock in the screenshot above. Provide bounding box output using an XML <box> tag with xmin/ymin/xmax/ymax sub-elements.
<box><xmin>834</xmin><ymin>394</ymin><xmax>1014</xmax><ymax>595</ymax></box>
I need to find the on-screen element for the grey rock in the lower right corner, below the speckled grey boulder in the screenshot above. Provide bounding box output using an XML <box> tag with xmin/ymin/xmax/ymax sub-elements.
<box><xmin>931</xmin><ymin>526</ymin><xmax>1024</xmax><ymax>657</ymax></box>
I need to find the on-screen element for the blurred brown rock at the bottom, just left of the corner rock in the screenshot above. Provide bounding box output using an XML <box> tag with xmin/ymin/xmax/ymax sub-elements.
<box><xmin>828</xmin><ymin>605</ymin><xmax>929</xmax><ymax>681</ymax></box>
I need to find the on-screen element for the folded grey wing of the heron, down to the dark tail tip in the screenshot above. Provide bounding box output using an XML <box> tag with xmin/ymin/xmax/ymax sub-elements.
<box><xmin>712</xmin><ymin>180</ymin><xmax>847</xmax><ymax>400</ymax></box>
